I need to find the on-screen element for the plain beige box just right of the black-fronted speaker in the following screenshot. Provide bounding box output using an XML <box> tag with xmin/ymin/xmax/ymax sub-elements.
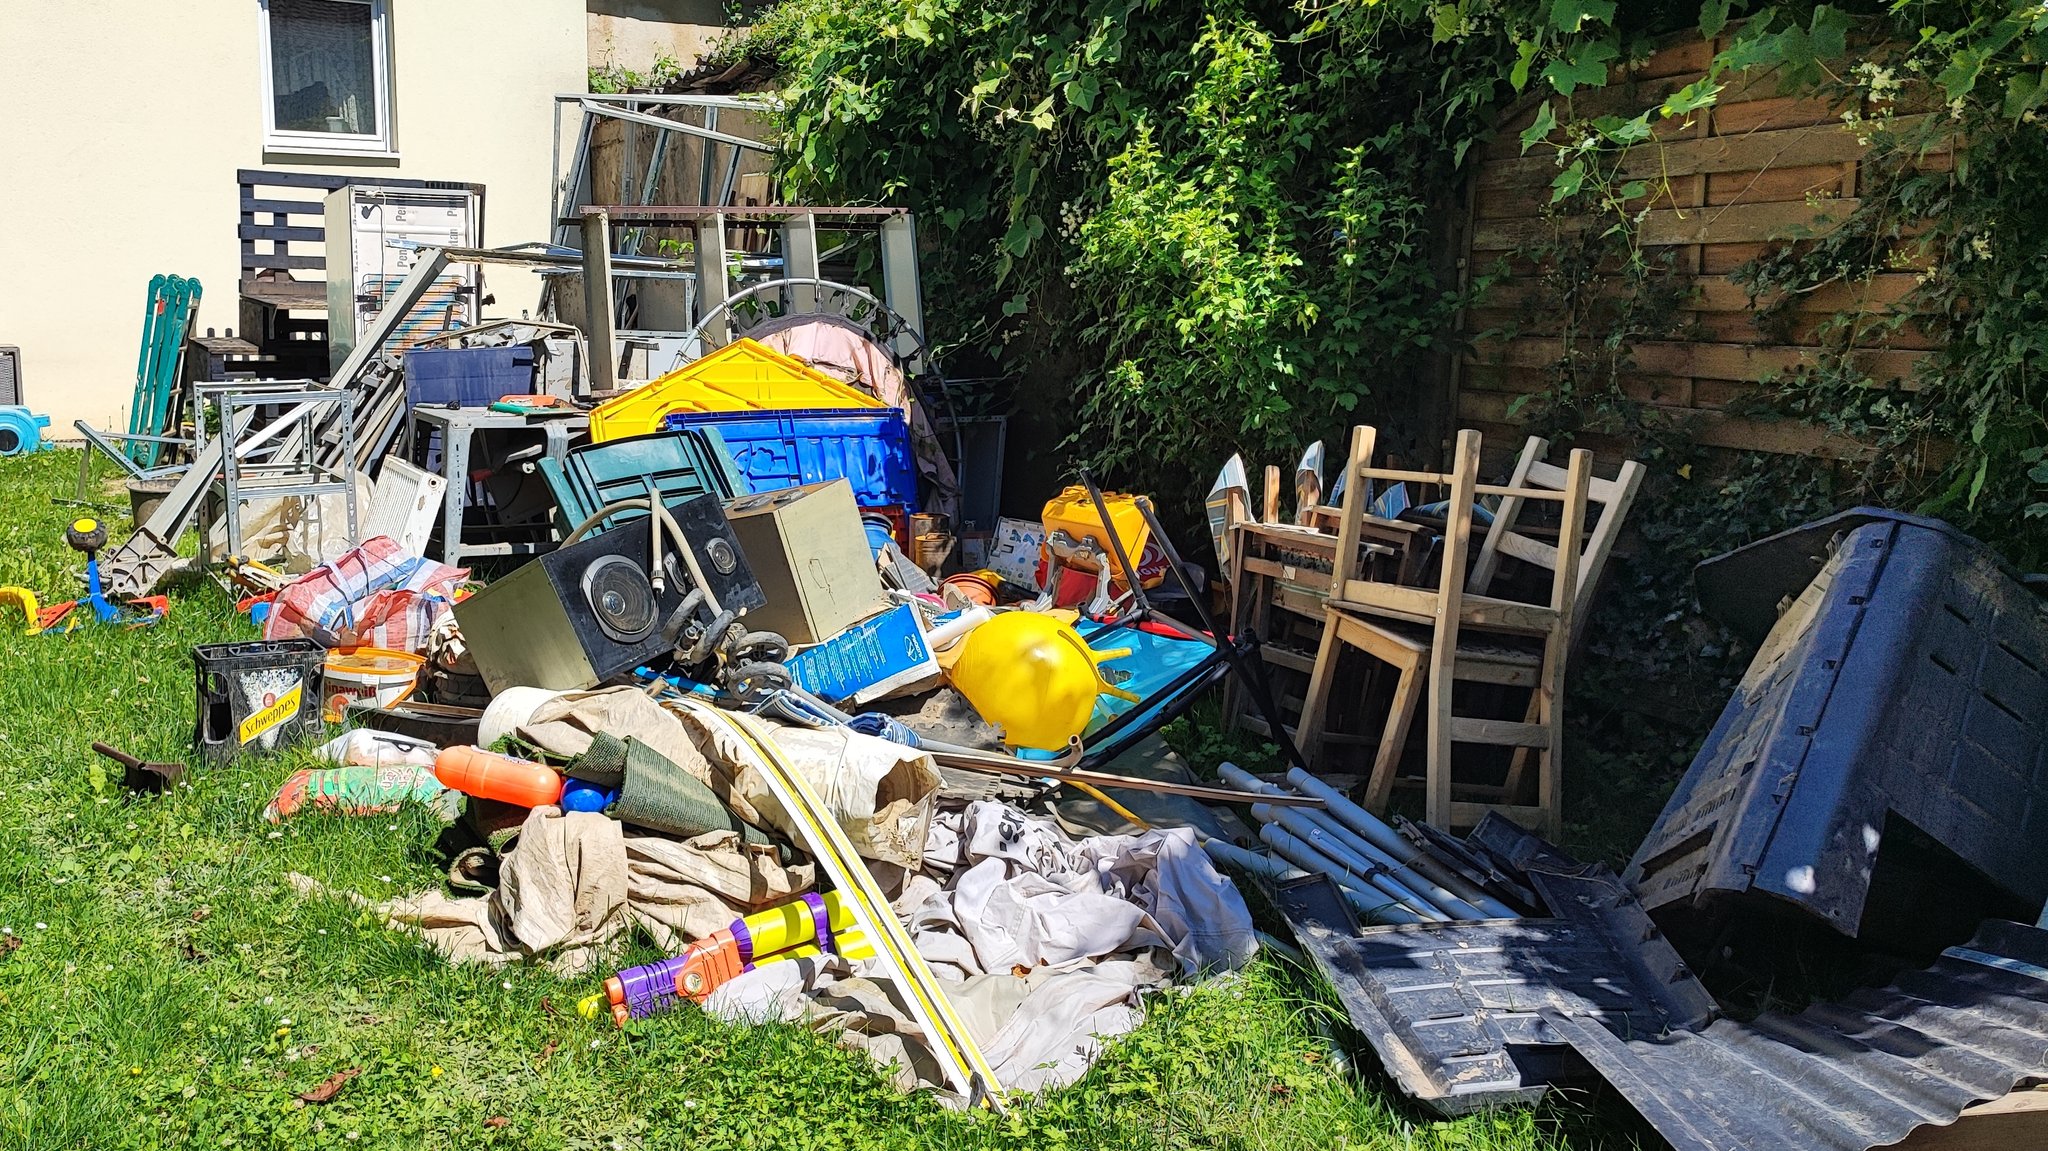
<box><xmin>725</xmin><ymin>479</ymin><xmax>885</xmax><ymax>643</ymax></box>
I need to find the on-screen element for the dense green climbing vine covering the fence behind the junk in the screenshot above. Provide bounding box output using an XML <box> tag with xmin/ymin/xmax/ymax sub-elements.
<box><xmin>700</xmin><ymin>0</ymin><xmax>2048</xmax><ymax>840</ymax></box>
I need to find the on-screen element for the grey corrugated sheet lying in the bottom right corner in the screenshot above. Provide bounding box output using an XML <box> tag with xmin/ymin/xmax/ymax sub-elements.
<box><xmin>1544</xmin><ymin>920</ymin><xmax>2048</xmax><ymax>1151</ymax></box>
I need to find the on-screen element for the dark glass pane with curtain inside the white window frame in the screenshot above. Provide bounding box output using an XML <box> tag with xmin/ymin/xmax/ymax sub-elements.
<box><xmin>270</xmin><ymin>0</ymin><xmax>379</xmax><ymax>135</ymax></box>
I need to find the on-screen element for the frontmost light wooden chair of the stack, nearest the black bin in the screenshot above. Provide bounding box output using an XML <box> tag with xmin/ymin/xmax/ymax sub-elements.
<box><xmin>1300</xmin><ymin>426</ymin><xmax>1591</xmax><ymax>836</ymax></box>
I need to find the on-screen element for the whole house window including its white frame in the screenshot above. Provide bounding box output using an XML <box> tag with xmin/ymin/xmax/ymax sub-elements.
<box><xmin>258</xmin><ymin>0</ymin><xmax>395</xmax><ymax>154</ymax></box>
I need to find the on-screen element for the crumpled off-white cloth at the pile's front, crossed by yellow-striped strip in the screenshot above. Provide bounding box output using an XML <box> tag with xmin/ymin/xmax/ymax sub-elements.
<box><xmin>705</xmin><ymin>801</ymin><xmax>1257</xmax><ymax>1092</ymax></box>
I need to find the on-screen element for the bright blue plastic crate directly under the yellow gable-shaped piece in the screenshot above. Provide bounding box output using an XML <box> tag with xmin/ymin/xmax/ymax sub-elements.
<box><xmin>664</xmin><ymin>408</ymin><xmax>918</xmax><ymax>508</ymax></box>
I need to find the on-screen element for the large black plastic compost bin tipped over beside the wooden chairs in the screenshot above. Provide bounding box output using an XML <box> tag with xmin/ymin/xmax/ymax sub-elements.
<box><xmin>1628</xmin><ymin>508</ymin><xmax>2048</xmax><ymax>938</ymax></box>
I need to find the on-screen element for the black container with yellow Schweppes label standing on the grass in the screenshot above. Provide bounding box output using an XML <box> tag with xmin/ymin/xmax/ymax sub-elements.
<box><xmin>193</xmin><ymin>639</ymin><xmax>328</xmax><ymax>764</ymax></box>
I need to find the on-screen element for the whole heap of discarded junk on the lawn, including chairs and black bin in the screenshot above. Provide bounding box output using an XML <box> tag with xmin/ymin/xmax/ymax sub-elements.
<box><xmin>19</xmin><ymin>199</ymin><xmax>2048</xmax><ymax>1149</ymax></box>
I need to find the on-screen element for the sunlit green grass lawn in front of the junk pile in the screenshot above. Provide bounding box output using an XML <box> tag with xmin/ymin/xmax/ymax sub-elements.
<box><xmin>0</xmin><ymin>451</ymin><xmax>1632</xmax><ymax>1151</ymax></box>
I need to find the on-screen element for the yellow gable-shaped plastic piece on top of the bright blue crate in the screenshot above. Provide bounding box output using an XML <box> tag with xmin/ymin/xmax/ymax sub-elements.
<box><xmin>590</xmin><ymin>338</ymin><xmax>883</xmax><ymax>442</ymax></box>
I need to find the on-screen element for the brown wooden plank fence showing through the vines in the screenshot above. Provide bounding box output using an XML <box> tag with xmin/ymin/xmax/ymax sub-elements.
<box><xmin>1450</xmin><ymin>35</ymin><xmax>1946</xmax><ymax>459</ymax></box>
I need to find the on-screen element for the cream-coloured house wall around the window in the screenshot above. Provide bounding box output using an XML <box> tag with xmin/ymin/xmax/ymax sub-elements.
<box><xmin>0</xmin><ymin>0</ymin><xmax>588</xmax><ymax>434</ymax></box>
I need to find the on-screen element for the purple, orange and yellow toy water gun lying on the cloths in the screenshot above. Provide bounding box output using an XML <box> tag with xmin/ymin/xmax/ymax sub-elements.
<box><xmin>590</xmin><ymin>891</ymin><xmax>874</xmax><ymax>1026</ymax></box>
